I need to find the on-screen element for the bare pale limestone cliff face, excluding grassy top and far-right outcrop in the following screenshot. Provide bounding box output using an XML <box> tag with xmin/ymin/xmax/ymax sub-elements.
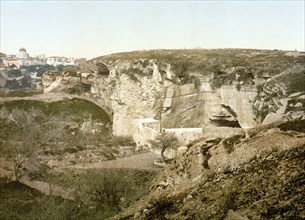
<box><xmin>43</xmin><ymin>60</ymin><xmax>255</xmax><ymax>144</ymax></box>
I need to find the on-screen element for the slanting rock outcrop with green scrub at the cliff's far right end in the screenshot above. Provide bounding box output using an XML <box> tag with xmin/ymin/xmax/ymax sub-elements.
<box><xmin>253</xmin><ymin>66</ymin><xmax>305</xmax><ymax>124</ymax></box>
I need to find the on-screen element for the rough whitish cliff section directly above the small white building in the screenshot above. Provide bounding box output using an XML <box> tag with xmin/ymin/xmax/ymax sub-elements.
<box><xmin>110</xmin><ymin>72</ymin><xmax>162</xmax><ymax>138</ymax></box>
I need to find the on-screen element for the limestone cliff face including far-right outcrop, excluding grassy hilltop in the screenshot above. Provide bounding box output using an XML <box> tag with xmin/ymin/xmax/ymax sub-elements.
<box><xmin>43</xmin><ymin>54</ymin><xmax>305</xmax><ymax>145</ymax></box>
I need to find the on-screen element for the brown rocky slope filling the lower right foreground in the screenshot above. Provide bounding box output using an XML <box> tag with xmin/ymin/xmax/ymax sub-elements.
<box><xmin>112</xmin><ymin>120</ymin><xmax>305</xmax><ymax>220</ymax></box>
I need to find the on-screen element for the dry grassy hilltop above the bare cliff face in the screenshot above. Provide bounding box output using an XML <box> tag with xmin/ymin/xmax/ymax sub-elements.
<box><xmin>93</xmin><ymin>49</ymin><xmax>305</xmax><ymax>88</ymax></box>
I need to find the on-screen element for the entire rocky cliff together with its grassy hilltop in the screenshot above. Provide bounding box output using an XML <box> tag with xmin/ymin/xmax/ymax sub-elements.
<box><xmin>44</xmin><ymin>50</ymin><xmax>305</xmax><ymax>144</ymax></box>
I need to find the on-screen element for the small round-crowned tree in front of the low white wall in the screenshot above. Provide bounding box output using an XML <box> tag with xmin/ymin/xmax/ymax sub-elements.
<box><xmin>149</xmin><ymin>132</ymin><xmax>179</xmax><ymax>161</ymax></box>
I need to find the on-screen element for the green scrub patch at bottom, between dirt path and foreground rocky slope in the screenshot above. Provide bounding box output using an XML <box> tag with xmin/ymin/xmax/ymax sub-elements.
<box><xmin>29</xmin><ymin>169</ymin><xmax>156</xmax><ymax>219</ymax></box>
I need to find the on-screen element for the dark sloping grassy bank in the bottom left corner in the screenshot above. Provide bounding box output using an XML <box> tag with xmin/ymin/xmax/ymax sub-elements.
<box><xmin>0</xmin><ymin>178</ymin><xmax>77</xmax><ymax>220</ymax></box>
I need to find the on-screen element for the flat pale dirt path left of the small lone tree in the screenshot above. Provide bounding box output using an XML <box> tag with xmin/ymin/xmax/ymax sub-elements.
<box><xmin>65</xmin><ymin>152</ymin><xmax>160</xmax><ymax>170</ymax></box>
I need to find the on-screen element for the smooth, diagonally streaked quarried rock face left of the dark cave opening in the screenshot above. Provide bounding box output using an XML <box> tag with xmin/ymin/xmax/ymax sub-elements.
<box><xmin>161</xmin><ymin>84</ymin><xmax>221</xmax><ymax>128</ymax></box>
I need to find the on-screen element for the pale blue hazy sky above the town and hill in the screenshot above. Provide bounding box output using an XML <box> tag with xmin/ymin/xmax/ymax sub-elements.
<box><xmin>0</xmin><ymin>0</ymin><xmax>305</xmax><ymax>58</ymax></box>
